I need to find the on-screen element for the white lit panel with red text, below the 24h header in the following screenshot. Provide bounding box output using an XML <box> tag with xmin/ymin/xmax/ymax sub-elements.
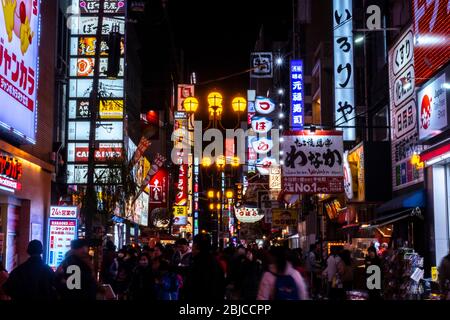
<box><xmin>47</xmin><ymin>219</ymin><xmax>77</xmax><ymax>269</ymax></box>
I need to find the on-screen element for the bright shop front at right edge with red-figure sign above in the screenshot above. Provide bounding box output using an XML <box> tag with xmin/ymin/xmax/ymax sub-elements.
<box><xmin>417</xmin><ymin>65</ymin><xmax>450</xmax><ymax>267</ymax></box>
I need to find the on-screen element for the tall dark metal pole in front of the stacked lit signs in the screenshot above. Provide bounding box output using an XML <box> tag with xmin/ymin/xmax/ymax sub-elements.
<box><xmin>84</xmin><ymin>0</ymin><xmax>105</xmax><ymax>239</ymax></box>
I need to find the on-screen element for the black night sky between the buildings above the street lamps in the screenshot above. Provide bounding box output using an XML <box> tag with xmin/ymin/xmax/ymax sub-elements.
<box><xmin>137</xmin><ymin>0</ymin><xmax>292</xmax><ymax>109</ymax></box>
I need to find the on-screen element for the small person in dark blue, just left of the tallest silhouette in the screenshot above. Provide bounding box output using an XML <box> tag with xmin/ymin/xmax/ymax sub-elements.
<box><xmin>155</xmin><ymin>259</ymin><xmax>181</xmax><ymax>301</ymax></box>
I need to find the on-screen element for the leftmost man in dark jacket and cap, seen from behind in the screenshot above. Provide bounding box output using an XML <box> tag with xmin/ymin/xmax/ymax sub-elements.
<box><xmin>3</xmin><ymin>240</ymin><xmax>57</xmax><ymax>301</ymax></box>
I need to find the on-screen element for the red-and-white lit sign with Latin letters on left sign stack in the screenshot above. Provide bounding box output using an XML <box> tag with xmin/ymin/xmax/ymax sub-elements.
<box><xmin>67</xmin><ymin>142</ymin><xmax>123</xmax><ymax>162</ymax></box>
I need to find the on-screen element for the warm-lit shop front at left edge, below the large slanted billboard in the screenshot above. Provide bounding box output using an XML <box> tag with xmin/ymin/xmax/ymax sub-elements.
<box><xmin>0</xmin><ymin>140</ymin><xmax>54</xmax><ymax>271</ymax></box>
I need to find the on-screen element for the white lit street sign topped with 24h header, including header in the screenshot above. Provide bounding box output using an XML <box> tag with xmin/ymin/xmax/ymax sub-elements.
<box><xmin>47</xmin><ymin>206</ymin><xmax>78</xmax><ymax>270</ymax></box>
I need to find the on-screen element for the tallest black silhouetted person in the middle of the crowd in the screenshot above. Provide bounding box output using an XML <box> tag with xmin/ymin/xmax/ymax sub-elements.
<box><xmin>185</xmin><ymin>234</ymin><xmax>225</xmax><ymax>302</ymax></box>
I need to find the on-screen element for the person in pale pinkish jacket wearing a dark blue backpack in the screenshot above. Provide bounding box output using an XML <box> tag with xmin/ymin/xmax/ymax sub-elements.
<box><xmin>257</xmin><ymin>247</ymin><xmax>308</xmax><ymax>300</ymax></box>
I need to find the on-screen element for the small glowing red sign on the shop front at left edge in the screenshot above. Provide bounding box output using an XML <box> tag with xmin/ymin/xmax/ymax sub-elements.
<box><xmin>0</xmin><ymin>152</ymin><xmax>23</xmax><ymax>192</ymax></box>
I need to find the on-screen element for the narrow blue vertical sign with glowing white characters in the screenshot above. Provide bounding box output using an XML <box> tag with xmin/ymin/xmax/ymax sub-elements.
<box><xmin>290</xmin><ymin>60</ymin><xmax>304</xmax><ymax>130</ymax></box>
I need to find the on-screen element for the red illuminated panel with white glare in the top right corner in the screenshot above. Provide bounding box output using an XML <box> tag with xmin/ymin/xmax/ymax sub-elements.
<box><xmin>412</xmin><ymin>0</ymin><xmax>450</xmax><ymax>84</ymax></box>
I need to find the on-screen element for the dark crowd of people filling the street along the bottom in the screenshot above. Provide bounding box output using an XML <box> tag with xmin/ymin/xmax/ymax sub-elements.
<box><xmin>0</xmin><ymin>234</ymin><xmax>450</xmax><ymax>302</ymax></box>
